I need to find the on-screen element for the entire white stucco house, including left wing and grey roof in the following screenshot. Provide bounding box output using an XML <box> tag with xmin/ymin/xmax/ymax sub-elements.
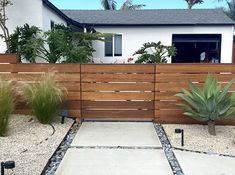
<box><xmin>0</xmin><ymin>0</ymin><xmax>235</xmax><ymax>63</ymax></box>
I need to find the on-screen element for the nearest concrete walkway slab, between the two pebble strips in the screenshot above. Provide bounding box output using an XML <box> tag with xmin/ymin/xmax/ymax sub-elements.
<box><xmin>55</xmin><ymin>148</ymin><xmax>173</xmax><ymax>175</ymax></box>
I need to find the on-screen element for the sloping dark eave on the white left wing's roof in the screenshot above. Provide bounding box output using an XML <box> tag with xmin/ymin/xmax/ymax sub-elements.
<box><xmin>43</xmin><ymin>0</ymin><xmax>86</xmax><ymax>29</ymax></box>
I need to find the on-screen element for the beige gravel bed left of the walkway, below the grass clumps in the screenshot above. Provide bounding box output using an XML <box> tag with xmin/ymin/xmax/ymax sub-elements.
<box><xmin>0</xmin><ymin>115</ymin><xmax>73</xmax><ymax>175</ymax></box>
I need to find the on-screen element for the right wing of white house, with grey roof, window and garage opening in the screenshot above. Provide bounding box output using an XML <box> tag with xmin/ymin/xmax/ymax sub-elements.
<box><xmin>62</xmin><ymin>9</ymin><xmax>234</xmax><ymax>63</ymax></box>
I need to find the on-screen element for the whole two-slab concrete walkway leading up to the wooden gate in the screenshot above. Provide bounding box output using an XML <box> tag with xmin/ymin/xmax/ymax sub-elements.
<box><xmin>55</xmin><ymin>122</ymin><xmax>173</xmax><ymax>175</ymax></box>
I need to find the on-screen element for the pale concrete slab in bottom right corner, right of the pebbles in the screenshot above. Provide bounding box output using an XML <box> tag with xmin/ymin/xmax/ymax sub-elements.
<box><xmin>174</xmin><ymin>151</ymin><xmax>235</xmax><ymax>175</ymax></box>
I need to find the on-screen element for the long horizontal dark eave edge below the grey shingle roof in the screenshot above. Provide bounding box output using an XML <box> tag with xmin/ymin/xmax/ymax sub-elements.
<box><xmin>84</xmin><ymin>23</ymin><xmax>235</xmax><ymax>27</ymax></box>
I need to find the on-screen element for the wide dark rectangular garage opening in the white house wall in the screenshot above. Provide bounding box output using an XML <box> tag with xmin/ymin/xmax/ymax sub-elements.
<box><xmin>172</xmin><ymin>34</ymin><xmax>221</xmax><ymax>63</ymax></box>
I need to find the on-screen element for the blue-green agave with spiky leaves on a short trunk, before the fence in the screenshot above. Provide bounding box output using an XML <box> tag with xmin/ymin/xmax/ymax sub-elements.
<box><xmin>176</xmin><ymin>75</ymin><xmax>235</xmax><ymax>135</ymax></box>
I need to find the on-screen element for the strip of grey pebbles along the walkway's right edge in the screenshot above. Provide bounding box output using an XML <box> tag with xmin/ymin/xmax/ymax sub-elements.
<box><xmin>154</xmin><ymin>124</ymin><xmax>184</xmax><ymax>175</ymax></box>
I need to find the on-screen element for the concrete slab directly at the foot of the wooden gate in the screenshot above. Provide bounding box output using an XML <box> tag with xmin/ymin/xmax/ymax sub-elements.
<box><xmin>71</xmin><ymin>122</ymin><xmax>162</xmax><ymax>147</ymax></box>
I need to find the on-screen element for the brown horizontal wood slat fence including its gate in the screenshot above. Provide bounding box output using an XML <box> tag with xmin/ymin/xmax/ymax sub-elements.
<box><xmin>0</xmin><ymin>55</ymin><xmax>235</xmax><ymax>125</ymax></box>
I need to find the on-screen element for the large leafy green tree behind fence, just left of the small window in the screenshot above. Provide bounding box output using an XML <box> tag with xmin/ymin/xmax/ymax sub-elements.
<box><xmin>41</xmin><ymin>25</ymin><xmax>105</xmax><ymax>63</ymax></box>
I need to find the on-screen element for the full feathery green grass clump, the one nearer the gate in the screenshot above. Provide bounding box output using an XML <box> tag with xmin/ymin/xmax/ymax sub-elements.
<box><xmin>23</xmin><ymin>74</ymin><xmax>65</xmax><ymax>124</ymax></box>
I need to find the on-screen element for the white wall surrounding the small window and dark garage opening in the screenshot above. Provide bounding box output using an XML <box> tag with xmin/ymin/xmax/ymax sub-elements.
<box><xmin>93</xmin><ymin>26</ymin><xmax>233</xmax><ymax>63</ymax></box>
